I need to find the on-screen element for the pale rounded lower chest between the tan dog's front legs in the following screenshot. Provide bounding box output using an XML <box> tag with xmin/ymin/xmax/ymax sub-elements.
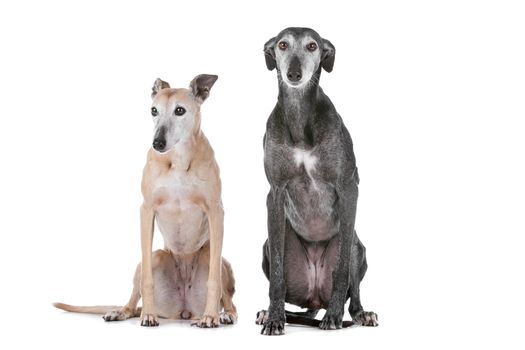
<box><xmin>155</xmin><ymin>205</ymin><xmax>209</xmax><ymax>255</ymax></box>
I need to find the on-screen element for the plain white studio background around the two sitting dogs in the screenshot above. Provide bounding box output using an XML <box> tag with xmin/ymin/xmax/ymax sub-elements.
<box><xmin>0</xmin><ymin>0</ymin><xmax>525</xmax><ymax>349</ymax></box>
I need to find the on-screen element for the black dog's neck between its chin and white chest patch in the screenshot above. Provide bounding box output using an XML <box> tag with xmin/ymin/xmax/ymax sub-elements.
<box><xmin>277</xmin><ymin>71</ymin><xmax>321</xmax><ymax>147</ymax></box>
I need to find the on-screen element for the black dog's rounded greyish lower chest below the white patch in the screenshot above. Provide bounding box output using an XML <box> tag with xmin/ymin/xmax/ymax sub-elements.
<box><xmin>285</xmin><ymin>176</ymin><xmax>339</xmax><ymax>242</ymax></box>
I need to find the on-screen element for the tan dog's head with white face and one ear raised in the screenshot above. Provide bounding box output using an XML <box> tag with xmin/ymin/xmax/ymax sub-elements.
<box><xmin>151</xmin><ymin>74</ymin><xmax>218</xmax><ymax>153</ymax></box>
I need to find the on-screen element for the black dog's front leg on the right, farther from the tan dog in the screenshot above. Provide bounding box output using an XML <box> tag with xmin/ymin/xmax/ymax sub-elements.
<box><xmin>319</xmin><ymin>177</ymin><xmax>358</xmax><ymax>329</ymax></box>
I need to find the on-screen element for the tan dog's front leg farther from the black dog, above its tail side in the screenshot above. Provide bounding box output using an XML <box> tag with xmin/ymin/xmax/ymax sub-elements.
<box><xmin>140</xmin><ymin>205</ymin><xmax>159</xmax><ymax>327</ymax></box>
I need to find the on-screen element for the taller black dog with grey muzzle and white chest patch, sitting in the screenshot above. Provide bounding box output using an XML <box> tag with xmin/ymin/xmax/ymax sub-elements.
<box><xmin>256</xmin><ymin>28</ymin><xmax>378</xmax><ymax>335</ymax></box>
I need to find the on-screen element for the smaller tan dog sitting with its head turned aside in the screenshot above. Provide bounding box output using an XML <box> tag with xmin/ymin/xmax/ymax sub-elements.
<box><xmin>54</xmin><ymin>74</ymin><xmax>237</xmax><ymax>328</ymax></box>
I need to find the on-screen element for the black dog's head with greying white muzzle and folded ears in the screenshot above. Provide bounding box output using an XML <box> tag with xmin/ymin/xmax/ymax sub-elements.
<box><xmin>264</xmin><ymin>28</ymin><xmax>335</xmax><ymax>88</ymax></box>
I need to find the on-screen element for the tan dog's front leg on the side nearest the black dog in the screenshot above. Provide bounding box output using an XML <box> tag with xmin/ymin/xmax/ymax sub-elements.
<box><xmin>195</xmin><ymin>202</ymin><xmax>224</xmax><ymax>328</ymax></box>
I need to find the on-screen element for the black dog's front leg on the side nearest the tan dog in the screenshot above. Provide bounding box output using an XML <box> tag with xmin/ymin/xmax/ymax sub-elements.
<box><xmin>261</xmin><ymin>187</ymin><xmax>286</xmax><ymax>335</ymax></box>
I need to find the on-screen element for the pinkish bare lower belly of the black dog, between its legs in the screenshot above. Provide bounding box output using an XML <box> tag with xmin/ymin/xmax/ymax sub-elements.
<box><xmin>285</xmin><ymin>233</ymin><xmax>338</xmax><ymax>310</ymax></box>
